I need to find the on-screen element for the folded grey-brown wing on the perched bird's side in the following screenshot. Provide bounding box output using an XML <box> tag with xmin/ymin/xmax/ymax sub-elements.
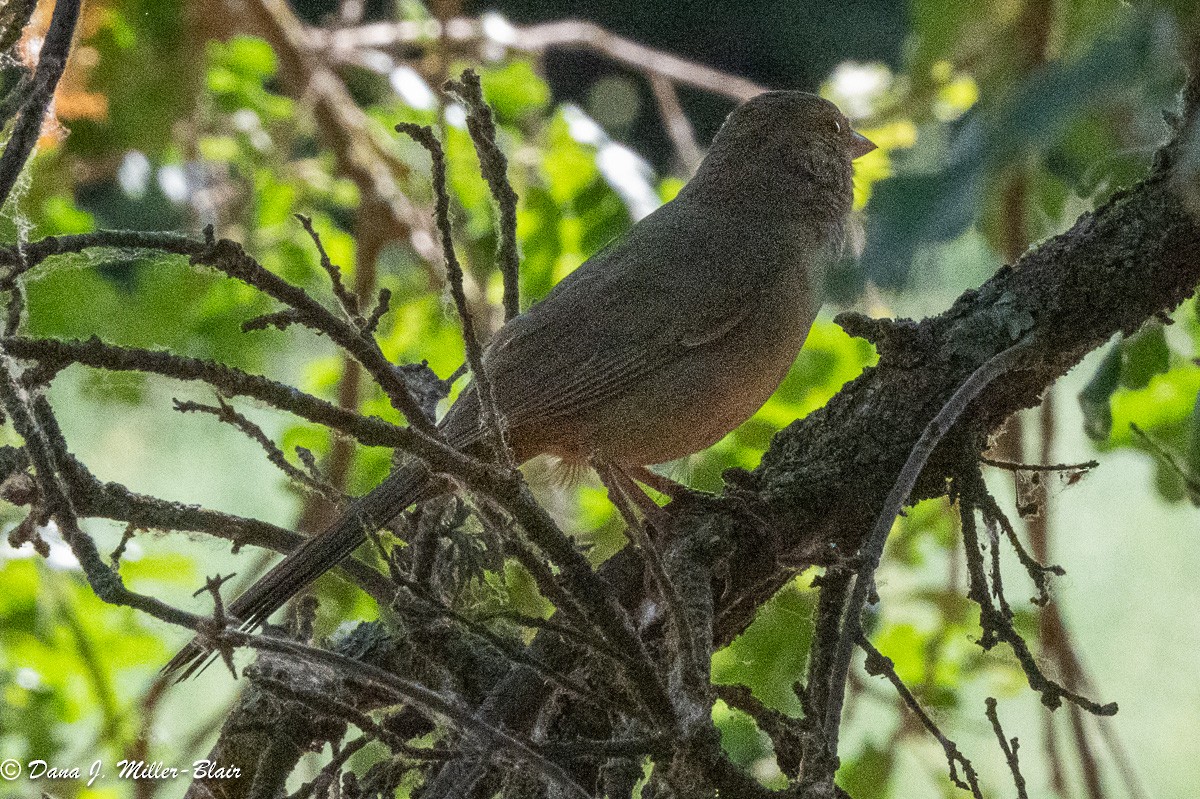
<box><xmin>472</xmin><ymin>205</ymin><xmax>761</xmax><ymax>426</ymax></box>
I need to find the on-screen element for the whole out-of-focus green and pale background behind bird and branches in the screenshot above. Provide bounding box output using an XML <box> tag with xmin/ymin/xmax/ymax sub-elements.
<box><xmin>0</xmin><ymin>0</ymin><xmax>1200</xmax><ymax>799</ymax></box>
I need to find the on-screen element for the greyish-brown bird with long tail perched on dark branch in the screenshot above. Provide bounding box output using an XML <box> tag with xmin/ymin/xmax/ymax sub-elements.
<box><xmin>163</xmin><ymin>91</ymin><xmax>875</xmax><ymax>679</ymax></box>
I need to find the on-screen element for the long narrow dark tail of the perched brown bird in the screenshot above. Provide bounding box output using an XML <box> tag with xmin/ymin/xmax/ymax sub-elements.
<box><xmin>162</xmin><ymin>464</ymin><xmax>428</xmax><ymax>681</ymax></box>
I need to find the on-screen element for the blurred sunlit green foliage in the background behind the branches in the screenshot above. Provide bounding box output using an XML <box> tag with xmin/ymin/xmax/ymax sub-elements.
<box><xmin>0</xmin><ymin>0</ymin><xmax>1200</xmax><ymax>799</ymax></box>
